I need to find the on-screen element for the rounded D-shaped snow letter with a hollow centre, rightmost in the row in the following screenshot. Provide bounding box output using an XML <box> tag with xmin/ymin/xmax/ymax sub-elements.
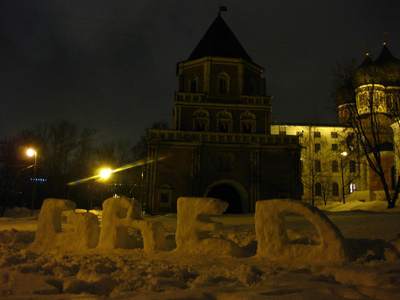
<box><xmin>255</xmin><ymin>200</ymin><xmax>347</xmax><ymax>265</ymax></box>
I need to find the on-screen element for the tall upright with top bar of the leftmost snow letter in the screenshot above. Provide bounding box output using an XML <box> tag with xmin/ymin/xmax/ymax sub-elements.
<box><xmin>31</xmin><ymin>199</ymin><xmax>75</xmax><ymax>252</ymax></box>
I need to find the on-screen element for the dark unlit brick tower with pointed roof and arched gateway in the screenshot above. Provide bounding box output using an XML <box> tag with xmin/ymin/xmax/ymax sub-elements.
<box><xmin>144</xmin><ymin>15</ymin><xmax>300</xmax><ymax>213</ymax></box>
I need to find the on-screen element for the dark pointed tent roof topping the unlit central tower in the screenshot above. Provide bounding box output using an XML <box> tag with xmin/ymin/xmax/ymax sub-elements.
<box><xmin>188</xmin><ymin>14</ymin><xmax>252</xmax><ymax>62</ymax></box>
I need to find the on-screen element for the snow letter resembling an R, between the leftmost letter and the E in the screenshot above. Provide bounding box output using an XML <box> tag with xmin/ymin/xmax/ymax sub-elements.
<box><xmin>98</xmin><ymin>197</ymin><xmax>166</xmax><ymax>252</ymax></box>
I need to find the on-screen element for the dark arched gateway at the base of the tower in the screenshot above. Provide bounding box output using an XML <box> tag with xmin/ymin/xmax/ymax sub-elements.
<box><xmin>205</xmin><ymin>180</ymin><xmax>248</xmax><ymax>214</ymax></box>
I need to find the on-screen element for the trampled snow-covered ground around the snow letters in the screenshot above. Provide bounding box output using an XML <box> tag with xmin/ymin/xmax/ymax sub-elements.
<box><xmin>0</xmin><ymin>203</ymin><xmax>400</xmax><ymax>300</ymax></box>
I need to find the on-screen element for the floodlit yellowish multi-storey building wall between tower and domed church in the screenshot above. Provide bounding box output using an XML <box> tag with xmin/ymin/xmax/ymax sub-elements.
<box><xmin>271</xmin><ymin>124</ymin><xmax>360</xmax><ymax>202</ymax></box>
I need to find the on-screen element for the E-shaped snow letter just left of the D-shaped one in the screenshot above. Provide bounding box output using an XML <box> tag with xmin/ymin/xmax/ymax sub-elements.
<box><xmin>176</xmin><ymin>197</ymin><xmax>242</xmax><ymax>256</ymax></box>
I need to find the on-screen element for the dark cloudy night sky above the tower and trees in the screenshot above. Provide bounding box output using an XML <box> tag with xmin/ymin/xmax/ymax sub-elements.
<box><xmin>0</xmin><ymin>0</ymin><xmax>400</xmax><ymax>140</ymax></box>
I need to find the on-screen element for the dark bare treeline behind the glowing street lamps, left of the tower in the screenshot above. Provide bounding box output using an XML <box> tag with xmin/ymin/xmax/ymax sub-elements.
<box><xmin>0</xmin><ymin>121</ymin><xmax>155</xmax><ymax>214</ymax></box>
